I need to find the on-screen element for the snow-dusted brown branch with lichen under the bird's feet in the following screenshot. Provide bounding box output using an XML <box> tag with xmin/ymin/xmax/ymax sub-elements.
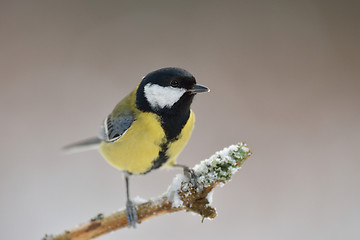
<box><xmin>43</xmin><ymin>142</ymin><xmax>251</xmax><ymax>240</ymax></box>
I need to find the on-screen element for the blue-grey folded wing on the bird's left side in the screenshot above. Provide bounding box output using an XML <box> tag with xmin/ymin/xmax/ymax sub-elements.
<box><xmin>99</xmin><ymin>113</ymin><xmax>134</xmax><ymax>142</ymax></box>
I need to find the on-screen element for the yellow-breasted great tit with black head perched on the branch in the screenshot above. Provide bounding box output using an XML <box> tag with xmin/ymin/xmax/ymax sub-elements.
<box><xmin>64</xmin><ymin>67</ymin><xmax>210</xmax><ymax>227</ymax></box>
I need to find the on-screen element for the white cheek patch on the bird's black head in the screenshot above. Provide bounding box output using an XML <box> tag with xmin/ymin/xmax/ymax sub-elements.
<box><xmin>144</xmin><ymin>83</ymin><xmax>186</xmax><ymax>109</ymax></box>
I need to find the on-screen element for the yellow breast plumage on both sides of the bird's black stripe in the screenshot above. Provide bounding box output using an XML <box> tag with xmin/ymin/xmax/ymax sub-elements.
<box><xmin>99</xmin><ymin>111</ymin><xmax>195</xmax><ymax>174</ymax></box>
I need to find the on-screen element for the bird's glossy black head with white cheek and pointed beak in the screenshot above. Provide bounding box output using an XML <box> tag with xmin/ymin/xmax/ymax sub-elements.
<box><xmin>136</xmin><ymin>68</ymin><xmax>209</xmax><ymax>114</ymax></box>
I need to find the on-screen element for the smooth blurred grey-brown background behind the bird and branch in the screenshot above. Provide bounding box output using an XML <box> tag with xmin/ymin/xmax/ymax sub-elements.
<box><xmin>0</xmin><ymin>0</ymin><xmax>360</xmax><ymax>240</ymax></box>
